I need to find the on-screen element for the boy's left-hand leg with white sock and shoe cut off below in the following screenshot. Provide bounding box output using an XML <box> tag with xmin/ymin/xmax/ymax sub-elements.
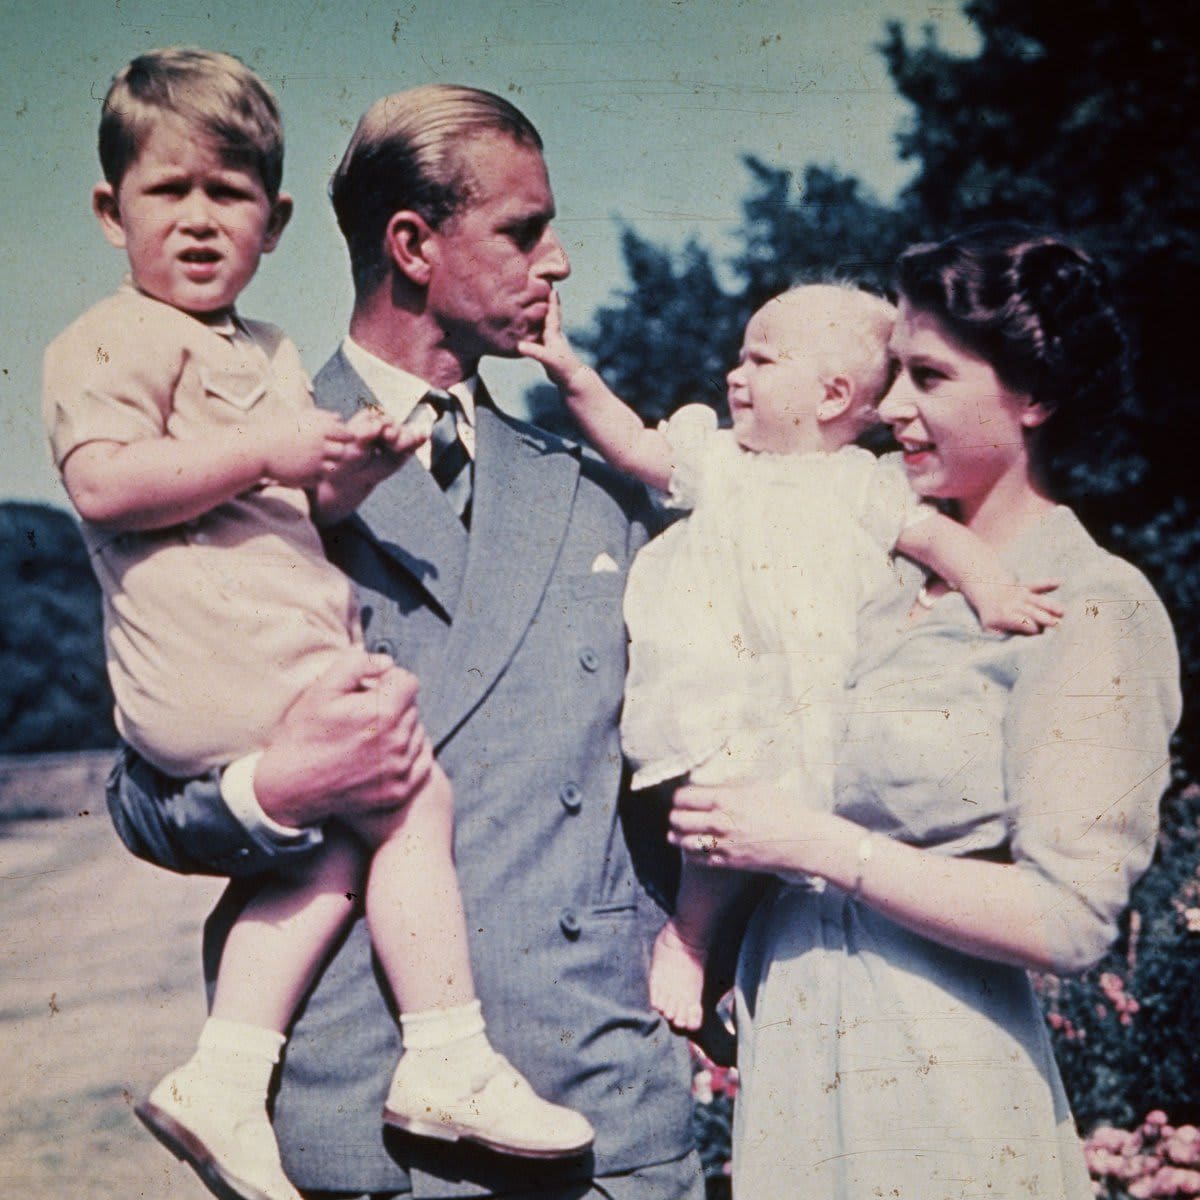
<box><xmin>137</xmin><ymin>828</ymin><xmax>366</xmax><ymax>1200</ymax></box>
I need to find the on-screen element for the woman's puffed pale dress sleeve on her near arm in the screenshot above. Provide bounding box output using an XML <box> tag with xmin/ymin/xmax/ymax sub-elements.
<box><xmin>1004</xmin><ymin>558</ymin><xmax>1180</xmax><ymax>971</ymax></box>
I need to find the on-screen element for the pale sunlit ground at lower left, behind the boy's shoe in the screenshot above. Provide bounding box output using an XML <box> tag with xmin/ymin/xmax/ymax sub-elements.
<box><xmin>0</xmin><ymin>811</ymin><xmax>221</xmax><ymax>1200</ymax></box>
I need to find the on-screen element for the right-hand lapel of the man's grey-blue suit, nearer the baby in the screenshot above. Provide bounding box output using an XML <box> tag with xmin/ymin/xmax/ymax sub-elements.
<box><xmin>421</xmin><ymin>398</ymin><xmax>580</xmax><ymax>743</ymax></box>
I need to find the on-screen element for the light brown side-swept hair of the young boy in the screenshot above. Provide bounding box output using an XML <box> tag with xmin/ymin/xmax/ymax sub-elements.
<box><xmin>100</xmin><ymin>46</ymin><xmax>283</xmax><ymax>200</ymax></box>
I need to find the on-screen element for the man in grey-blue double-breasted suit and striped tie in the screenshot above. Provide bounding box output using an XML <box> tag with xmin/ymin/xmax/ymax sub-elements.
<box><xmin>109</xmin><ymin>85</ymin><xmax>703</xmax><ymax>1200</ymax></box>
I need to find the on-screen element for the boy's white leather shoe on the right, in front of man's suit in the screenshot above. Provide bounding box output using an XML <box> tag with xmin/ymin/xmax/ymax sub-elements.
<box><xmin>383</xmin><ymin>1054</ymin><xmax>595</xmax><ymax>1158</ymax></box>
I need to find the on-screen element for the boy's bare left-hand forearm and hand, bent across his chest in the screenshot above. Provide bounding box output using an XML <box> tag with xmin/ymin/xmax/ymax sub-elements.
<box><xmin>62</xmin><ymin>409</ymin><xmax>355</xmax><ymax>532</ymax></box>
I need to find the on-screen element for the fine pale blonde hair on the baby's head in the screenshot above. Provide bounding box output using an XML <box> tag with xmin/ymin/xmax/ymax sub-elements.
<box><xmin>768</xmin><ymin>280</ymin><xmax>896</xmax><ymax>432</ymax></box>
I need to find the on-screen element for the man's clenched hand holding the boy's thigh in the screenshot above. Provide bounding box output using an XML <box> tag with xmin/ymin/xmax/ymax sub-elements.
<box><xmin>254</xmin><ymin>649</ymin><xmax>433</xmax><ymax>827</ymax></box>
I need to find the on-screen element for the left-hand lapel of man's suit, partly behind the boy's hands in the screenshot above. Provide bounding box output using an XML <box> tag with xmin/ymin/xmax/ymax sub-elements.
<box><xmin>316</xmin><ymin>350</ymin><xmax>467</xmax><ymax>618</ymax></box>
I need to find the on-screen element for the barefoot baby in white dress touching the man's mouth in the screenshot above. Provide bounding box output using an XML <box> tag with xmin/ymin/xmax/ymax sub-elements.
<box><xmin>521</xmin><ymin>284</ymin><xmax>1062</xmax><ymax>1030</ymax></box>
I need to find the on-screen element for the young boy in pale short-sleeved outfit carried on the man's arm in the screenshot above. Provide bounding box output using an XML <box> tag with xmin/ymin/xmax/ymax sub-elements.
<box><xmin>43</xmin><ymin>49</ymin><xmax>593</xmax><ymax>1200</ymax></box>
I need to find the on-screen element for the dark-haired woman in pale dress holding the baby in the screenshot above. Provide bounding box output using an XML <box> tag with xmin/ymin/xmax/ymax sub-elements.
<box><xmin>672</xmin><ymin>226</ymin><xmax>1180</xmax><ymax>1200</ymax></box>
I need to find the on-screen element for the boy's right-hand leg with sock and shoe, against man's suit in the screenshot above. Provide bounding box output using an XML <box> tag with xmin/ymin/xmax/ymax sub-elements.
<box><xmin>353</xmin><ymin>764</ymin><xmax>593</xmax><ymax>1158</ymax></box>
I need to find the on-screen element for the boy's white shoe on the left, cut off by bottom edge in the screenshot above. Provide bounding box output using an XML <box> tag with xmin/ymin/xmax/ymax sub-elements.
<box><xmin>133</xmin><ymin>1063</ymin><xmax>304</xmax><ymax>1200</ymax></box>
